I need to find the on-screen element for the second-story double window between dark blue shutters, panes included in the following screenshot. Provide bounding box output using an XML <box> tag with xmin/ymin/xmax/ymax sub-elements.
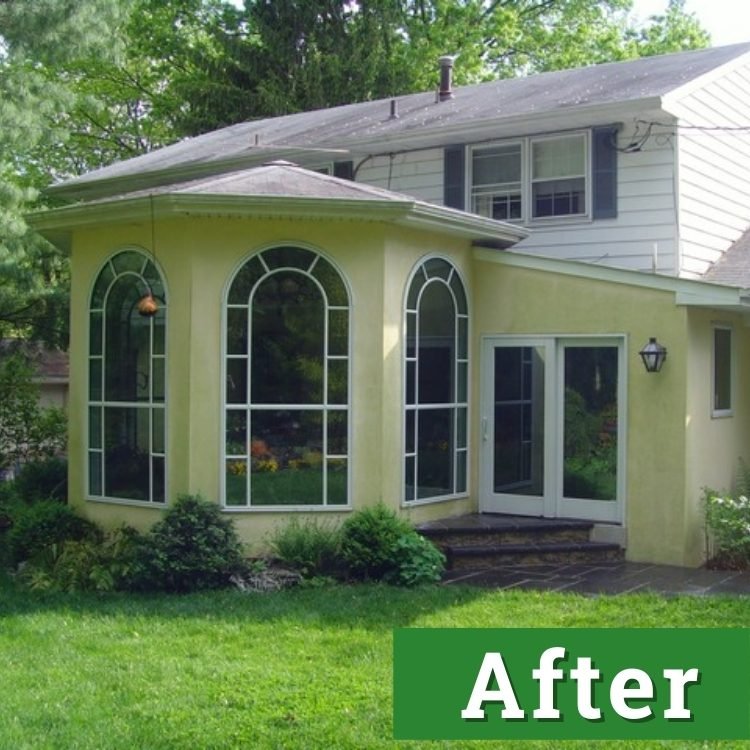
<box><xmin>470</xmin><ymin>133</ymin><xmax>591</xmax><ymax>222</ymax></box>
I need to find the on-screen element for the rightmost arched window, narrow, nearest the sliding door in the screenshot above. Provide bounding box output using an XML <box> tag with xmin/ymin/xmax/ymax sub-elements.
<box><xmin>404</xmin><ymin>258</ymin><xmax>469</xmax><ymax>502</ymax></box>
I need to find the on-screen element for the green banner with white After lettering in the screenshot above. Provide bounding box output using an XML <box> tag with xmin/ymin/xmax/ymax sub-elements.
<box><xmin>393</xmin><ymin>628</ymin><xmax>750</xmax><ymax>740</ymax></box>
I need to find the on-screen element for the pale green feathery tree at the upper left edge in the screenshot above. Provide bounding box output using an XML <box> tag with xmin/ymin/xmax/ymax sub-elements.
<box><xmin>0</xmin><ymin>0</ymin><xmax>127</xmax><ymax>344</ymax></box>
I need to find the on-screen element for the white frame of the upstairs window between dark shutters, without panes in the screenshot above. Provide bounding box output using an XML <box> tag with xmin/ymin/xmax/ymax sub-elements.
<box><xmin>466</xmin><ymin>130</ymin><xmax>593</xmax><ymax>226</ymax></box>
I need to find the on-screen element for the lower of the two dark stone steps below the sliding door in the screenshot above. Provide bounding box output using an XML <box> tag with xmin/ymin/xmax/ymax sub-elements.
<box><xmin>441</xmin><ymin>541</ymin><xmax>624</xmax><ymax>570</ymax></box>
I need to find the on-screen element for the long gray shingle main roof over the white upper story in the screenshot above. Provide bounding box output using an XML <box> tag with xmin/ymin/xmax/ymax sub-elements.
<box><xmin>52</xmin><ymin>44</ymin><xmax>750</xmax><ymax>197</ymax></box>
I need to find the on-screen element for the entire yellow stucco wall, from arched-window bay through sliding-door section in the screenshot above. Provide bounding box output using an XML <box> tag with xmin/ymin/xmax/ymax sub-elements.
<box><xmin>69</xmin><ymin>212</ymin><xmax>750</xmax><ymax>565</ymax></box>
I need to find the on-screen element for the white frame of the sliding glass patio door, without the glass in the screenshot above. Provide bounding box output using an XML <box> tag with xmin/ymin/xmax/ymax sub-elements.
<box><xmin>479</xmin><ymin>334</ymin><xmax>627</xmax><ymax>524</ymax></box>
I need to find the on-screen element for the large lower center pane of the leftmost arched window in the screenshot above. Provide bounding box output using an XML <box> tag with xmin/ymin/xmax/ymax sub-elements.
<box><xmin>104</xmin><ymin>407</ymin><xmax>150</xmax><ymax>500</ymax></box>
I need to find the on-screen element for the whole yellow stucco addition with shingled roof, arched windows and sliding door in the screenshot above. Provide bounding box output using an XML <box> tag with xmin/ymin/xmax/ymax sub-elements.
<box><xmin>32</xmin><ymin>162</ymin><xmax>750</xmax><ymax>565</ymax></box>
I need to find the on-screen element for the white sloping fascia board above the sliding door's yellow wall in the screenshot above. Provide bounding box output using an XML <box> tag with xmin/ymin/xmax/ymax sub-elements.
<box><xmin>474</xmin><ymin>248</ymin><xmax>750</xmax><ymax>312</ymax></box>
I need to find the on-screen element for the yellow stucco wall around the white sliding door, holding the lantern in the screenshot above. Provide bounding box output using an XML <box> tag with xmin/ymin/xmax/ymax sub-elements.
<box><xmin>473</xmin><ymin>261</ymin><xmax>699</xmax><ymax>564</ymax></box>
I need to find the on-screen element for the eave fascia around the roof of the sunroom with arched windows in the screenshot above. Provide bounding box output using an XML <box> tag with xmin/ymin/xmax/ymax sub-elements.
<box><xmin>26</xmin><ymin>194</ymin><xmax>527</xmax><ymax>247</ymax></box>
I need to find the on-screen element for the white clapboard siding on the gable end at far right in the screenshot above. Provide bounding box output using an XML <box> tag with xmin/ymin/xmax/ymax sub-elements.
<box><xmin>670</xmin><ymin>65</ymin><xmax>750</xmax><ymax>276</ymax></box>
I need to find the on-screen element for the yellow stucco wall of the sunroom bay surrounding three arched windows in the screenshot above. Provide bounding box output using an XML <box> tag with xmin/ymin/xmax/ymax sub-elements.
<box><xmin>70</xmin><ymin>218</ymin><xmax>472</xmax><ymax>545</ymax></box>
